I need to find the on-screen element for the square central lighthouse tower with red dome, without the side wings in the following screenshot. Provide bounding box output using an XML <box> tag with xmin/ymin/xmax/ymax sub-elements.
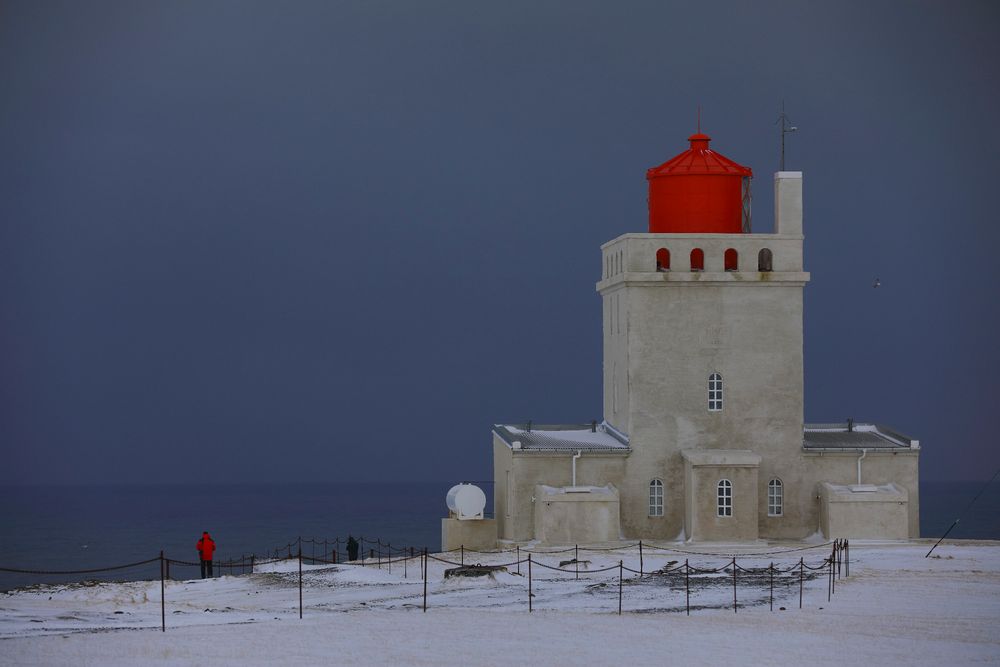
<box><xmin>597</xmin><ymin>133</ymin><xmax>812</xmax><ymax>540</ymax></box>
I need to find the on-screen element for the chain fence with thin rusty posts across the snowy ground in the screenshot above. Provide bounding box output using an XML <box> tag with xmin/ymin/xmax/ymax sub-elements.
<box><xmin>0</xmin><ymin>537</ymin><xmax>851</xmax><ymax>632</ymax></box>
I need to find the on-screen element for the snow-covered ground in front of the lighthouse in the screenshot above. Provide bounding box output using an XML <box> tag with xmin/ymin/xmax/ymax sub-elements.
<box><xmin>0</xmin><ymin>542</ymin><xmax>1000</xmax><ymax>665</ymax></box>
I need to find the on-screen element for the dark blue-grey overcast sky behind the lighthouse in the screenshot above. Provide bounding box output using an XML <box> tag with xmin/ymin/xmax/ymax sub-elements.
<box><xmin>0</xmin><ymin>0</ymin><xmax>1000</xmax><ymax>483</ymax></box>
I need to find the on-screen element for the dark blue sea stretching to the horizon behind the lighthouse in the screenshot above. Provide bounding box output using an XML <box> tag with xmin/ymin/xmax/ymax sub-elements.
<box><xmin>0</xmin><ymin>480</ymin><xmax>1000</xmax><ymax>591</ymax></box>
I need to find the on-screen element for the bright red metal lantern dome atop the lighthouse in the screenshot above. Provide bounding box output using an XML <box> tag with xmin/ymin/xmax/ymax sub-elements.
<box><xmin>646</xmin><ymin>132</ymin><xmax>753</xmax><ymax>234</ymax></box>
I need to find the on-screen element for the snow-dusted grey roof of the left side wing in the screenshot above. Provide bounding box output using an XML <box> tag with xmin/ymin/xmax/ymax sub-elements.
<box><xmin>493</xmin><ymin>422</ymin><xmax>631</xmax><ymax>454</ymax></box>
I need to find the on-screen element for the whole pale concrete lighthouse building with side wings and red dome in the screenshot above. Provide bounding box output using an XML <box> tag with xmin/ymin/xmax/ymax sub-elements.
<box><xmin>493</xmin><ymin>134</ymin><xmax>920</xmax><ymax>543</ymax></box>
